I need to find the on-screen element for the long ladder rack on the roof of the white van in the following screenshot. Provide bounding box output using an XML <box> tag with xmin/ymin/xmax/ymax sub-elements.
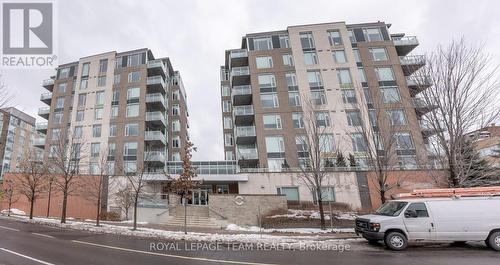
<box><xmin>393</xmin><ymin>186</ymin><xmax>500</xmax><ymax>199</ymax></box>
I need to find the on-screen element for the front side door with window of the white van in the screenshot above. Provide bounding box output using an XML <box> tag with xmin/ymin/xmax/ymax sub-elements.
<box><xmin>403</xmin><ymin>202</ymin><xmax>435</xmax><ymax>240</ymax></box>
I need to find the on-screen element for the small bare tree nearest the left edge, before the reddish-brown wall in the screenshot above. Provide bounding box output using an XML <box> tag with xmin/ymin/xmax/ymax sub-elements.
<box><xmin>15</xmin><ymin>155</ymin><xmax>48</xmax><ymax>219</ymax></box>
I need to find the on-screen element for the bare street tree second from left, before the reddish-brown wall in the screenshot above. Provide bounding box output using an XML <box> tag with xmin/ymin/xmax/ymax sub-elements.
<box><xmin>49</xmin><ymin>129</ymin><xmax>85</xmax><ymax>223</ymax></box>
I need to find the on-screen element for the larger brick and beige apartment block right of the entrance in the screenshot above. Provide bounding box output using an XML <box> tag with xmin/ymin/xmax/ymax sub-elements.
<box><xmin>220</xmin><ymin>22</ymin><xmax>434</xmax><ymax>171</ymax></box>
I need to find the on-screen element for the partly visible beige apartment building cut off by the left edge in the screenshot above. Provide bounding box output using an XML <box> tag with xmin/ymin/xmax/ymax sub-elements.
<box><xmin>0</xmin><ymin>107</ymin><xmax>43</xmax><ymax>181</ymax></box>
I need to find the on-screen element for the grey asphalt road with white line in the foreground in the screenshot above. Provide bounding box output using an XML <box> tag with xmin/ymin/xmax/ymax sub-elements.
<box><xmin>0</xmin><ymin>218</ymin><xmax>500</xmax><ymax>265</ymax></box>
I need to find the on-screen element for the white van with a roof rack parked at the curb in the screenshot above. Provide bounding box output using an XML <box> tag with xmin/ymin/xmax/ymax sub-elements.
<box><xmin>355</xmin><ymin>196</ymin><xmax>500</xmax><ymax>251</ymax></box>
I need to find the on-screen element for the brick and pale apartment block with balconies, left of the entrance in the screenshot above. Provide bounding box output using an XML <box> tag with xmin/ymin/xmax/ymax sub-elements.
<box><xmin>36</xmin><ymin>48</ymin><xmax>188</xmax><ymax>174</ymax></box>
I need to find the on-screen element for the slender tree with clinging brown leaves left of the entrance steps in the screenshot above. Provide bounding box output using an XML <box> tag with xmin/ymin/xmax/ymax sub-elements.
<box><xmin>167</xmin><ymin>140</ymin><xmax>199</xmax><ymax>234</ymax></box>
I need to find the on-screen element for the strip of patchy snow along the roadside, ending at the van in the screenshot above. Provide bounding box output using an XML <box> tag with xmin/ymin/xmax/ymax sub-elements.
<box><xmin>0</xmin><ymin>213</ymin><xmax>359</xmax><ymax>249</ymax></box>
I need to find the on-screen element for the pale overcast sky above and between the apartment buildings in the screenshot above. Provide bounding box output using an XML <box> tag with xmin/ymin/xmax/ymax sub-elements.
<box><xmin>0</xmin><ymin>0</ymin><xmax>500</xmax><ymax>160</ymax></box>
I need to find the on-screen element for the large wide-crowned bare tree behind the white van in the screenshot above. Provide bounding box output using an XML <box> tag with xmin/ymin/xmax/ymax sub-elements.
<box><xmin>415</xmin><ymin>39</ymin><xmax>500</xmax><ymax>187</ymax></box>
